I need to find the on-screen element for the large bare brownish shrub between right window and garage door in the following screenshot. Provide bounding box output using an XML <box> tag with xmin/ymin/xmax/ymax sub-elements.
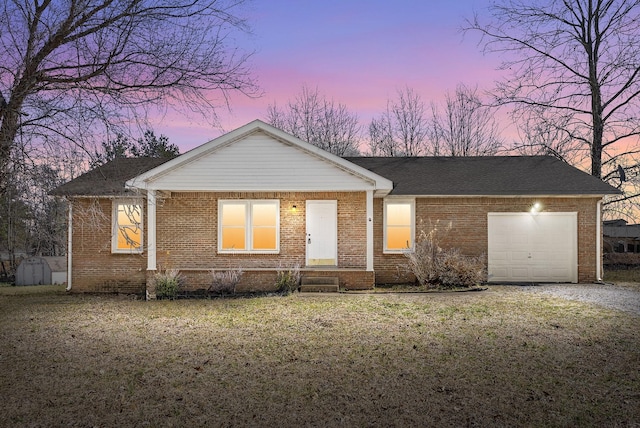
<box><xmin>405</xmin><ymin>223</ymin><xmax>486</xmax><ymax>288</ymax></box>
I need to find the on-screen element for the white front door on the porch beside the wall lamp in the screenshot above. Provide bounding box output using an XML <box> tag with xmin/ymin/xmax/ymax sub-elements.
<box><xmin>306</xmin><ymin>201</ymin><xmax>338</xmax><ymax>266</ymax></box>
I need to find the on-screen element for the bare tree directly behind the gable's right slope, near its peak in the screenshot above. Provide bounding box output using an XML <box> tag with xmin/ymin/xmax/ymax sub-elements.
<box><xmin>266</xmin><ymin>86</ymin><xmax>360</xmax><ymax>156</ymax></box>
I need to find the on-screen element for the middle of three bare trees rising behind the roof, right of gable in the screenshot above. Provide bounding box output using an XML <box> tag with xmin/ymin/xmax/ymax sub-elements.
<box><xmin>369</xmin><ymin>87</ymin><xmax>429</xmax><ymax>156</ymax></box>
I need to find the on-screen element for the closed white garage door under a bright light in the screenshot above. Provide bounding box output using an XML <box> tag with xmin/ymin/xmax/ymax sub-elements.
<box><xmin>488</xmin><ymin>213</ymin><xmax>578</xmax><ymax>282</ymax></box>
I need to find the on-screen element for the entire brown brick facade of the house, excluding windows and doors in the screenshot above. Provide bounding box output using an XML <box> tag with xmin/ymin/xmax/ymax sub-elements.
<box><xmin>72</xmin><ymin>192</ymin><xmax>597</xmax><ymax>293</ymax></box>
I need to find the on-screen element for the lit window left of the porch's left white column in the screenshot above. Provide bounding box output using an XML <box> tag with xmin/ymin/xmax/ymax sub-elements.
<box><xmin>111</xmin><ymin>201</ymin><xmax>142</xmax><ymax>254</ymax></box>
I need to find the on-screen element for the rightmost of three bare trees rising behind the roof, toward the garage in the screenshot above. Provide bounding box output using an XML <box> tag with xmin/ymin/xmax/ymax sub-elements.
<box><xmin>429</xmin><ymin>84</ymin><xmax>504</xmax><ymax>156</ymax></box>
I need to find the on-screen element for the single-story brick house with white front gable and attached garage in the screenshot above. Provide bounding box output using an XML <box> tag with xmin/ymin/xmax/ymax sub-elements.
<box><xmin>52</xmin><ymin>121</ymin><xmax>618</xmax><ymax>297</ymax></box>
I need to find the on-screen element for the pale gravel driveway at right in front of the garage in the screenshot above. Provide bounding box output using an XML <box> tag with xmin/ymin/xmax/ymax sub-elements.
<box><xmin>522</xmin><ymin>284</ymin><xmax>640</xmax><ymax>315</ymax></box>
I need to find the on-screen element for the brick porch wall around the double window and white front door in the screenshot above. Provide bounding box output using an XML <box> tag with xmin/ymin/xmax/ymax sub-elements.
<box><xmin>156</xmin><ymin>192</ymin><xmax>366</xmax><ymax>269</ymax></box>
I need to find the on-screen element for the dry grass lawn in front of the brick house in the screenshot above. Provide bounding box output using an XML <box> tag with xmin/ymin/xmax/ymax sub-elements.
<box><xmin>0</xmin><ymin>287</ymin><xmax>640</xmax><ymax>427</ymax></box>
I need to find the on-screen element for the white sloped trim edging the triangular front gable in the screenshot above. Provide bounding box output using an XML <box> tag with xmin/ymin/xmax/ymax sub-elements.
<box><xmin>126</xmin><ymin>120</ymin><xmax>393</xmax><ymax>196</ymax></box>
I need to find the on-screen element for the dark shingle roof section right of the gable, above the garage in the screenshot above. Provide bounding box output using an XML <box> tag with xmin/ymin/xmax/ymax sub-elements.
<box><xmin>346</xmin><ymin>156</ymin><xmax>620</xmax><ymax>196</ymax></box>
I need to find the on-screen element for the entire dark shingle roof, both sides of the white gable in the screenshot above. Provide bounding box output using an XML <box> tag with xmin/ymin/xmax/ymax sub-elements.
<box><xmin>50</xmin><ymin>156</ymin><xmax>620</xmax><ymax>196</ymax></box>
